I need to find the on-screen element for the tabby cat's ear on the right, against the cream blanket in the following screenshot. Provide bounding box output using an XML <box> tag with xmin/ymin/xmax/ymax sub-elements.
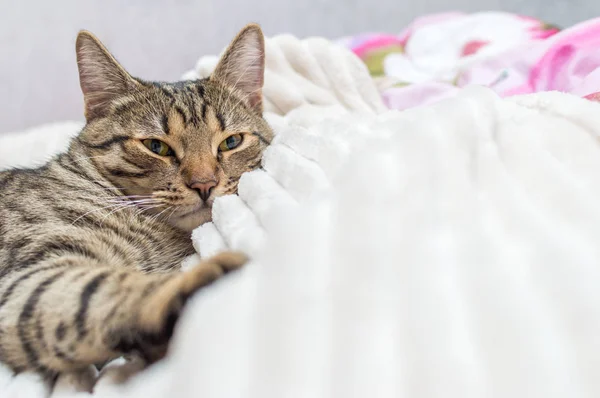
<box><xmin>211</xmin><ymin>24</ymin><xmax>265</xmax><ymax>113</ymax></box>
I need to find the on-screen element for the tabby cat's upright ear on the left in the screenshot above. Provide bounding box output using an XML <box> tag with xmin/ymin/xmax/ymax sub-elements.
<box><xmin>75</xmin><ymin>31</ymin><xmax>140</xmax><ymax>121</ymax></box>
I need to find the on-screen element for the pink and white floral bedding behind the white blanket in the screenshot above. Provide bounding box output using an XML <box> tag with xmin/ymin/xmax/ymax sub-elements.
<box><xmin>340</xmin><ymin>12</ymin><xmax>600</xmax><ymax>109</ymax></box>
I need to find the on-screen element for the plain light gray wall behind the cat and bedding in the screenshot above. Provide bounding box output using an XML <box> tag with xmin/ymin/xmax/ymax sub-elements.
<box><xmin>0</xmin><ymin>0</ymin><xmax>600</xmax><ymax>132</ymax></box>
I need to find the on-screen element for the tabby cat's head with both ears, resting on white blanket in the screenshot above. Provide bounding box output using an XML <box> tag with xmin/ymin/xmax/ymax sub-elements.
<box><xmin>73</xmin><ymin>25</ymin><xmax>273</xmax><ymax>230</ymax></box>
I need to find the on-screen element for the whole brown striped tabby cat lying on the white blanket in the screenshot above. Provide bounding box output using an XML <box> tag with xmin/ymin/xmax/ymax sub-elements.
<box><xmin>0</xmin><ymin>24</ymin><xmax>273</xmax><ymax>377</ymax></box>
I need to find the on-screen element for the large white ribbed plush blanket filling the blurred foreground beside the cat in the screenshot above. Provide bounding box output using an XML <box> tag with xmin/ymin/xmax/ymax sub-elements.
<box><xmin>0</xmin><ymin>35</ymin><xmax>600</xmax><ymax>398</ymax></box>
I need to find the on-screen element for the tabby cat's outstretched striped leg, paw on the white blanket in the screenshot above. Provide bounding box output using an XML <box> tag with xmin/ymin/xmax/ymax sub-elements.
<box><xmin>0</xmin><ymin>252</ymin><xmax>247</xmax><ymax>375</ymax></box>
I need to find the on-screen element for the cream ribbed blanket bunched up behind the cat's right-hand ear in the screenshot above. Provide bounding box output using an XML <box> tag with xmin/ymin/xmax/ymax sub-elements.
<box><xmin>184</xmin><ymin>35</ymin><xmax>385</xmax><ymax>115</ymax></box>
